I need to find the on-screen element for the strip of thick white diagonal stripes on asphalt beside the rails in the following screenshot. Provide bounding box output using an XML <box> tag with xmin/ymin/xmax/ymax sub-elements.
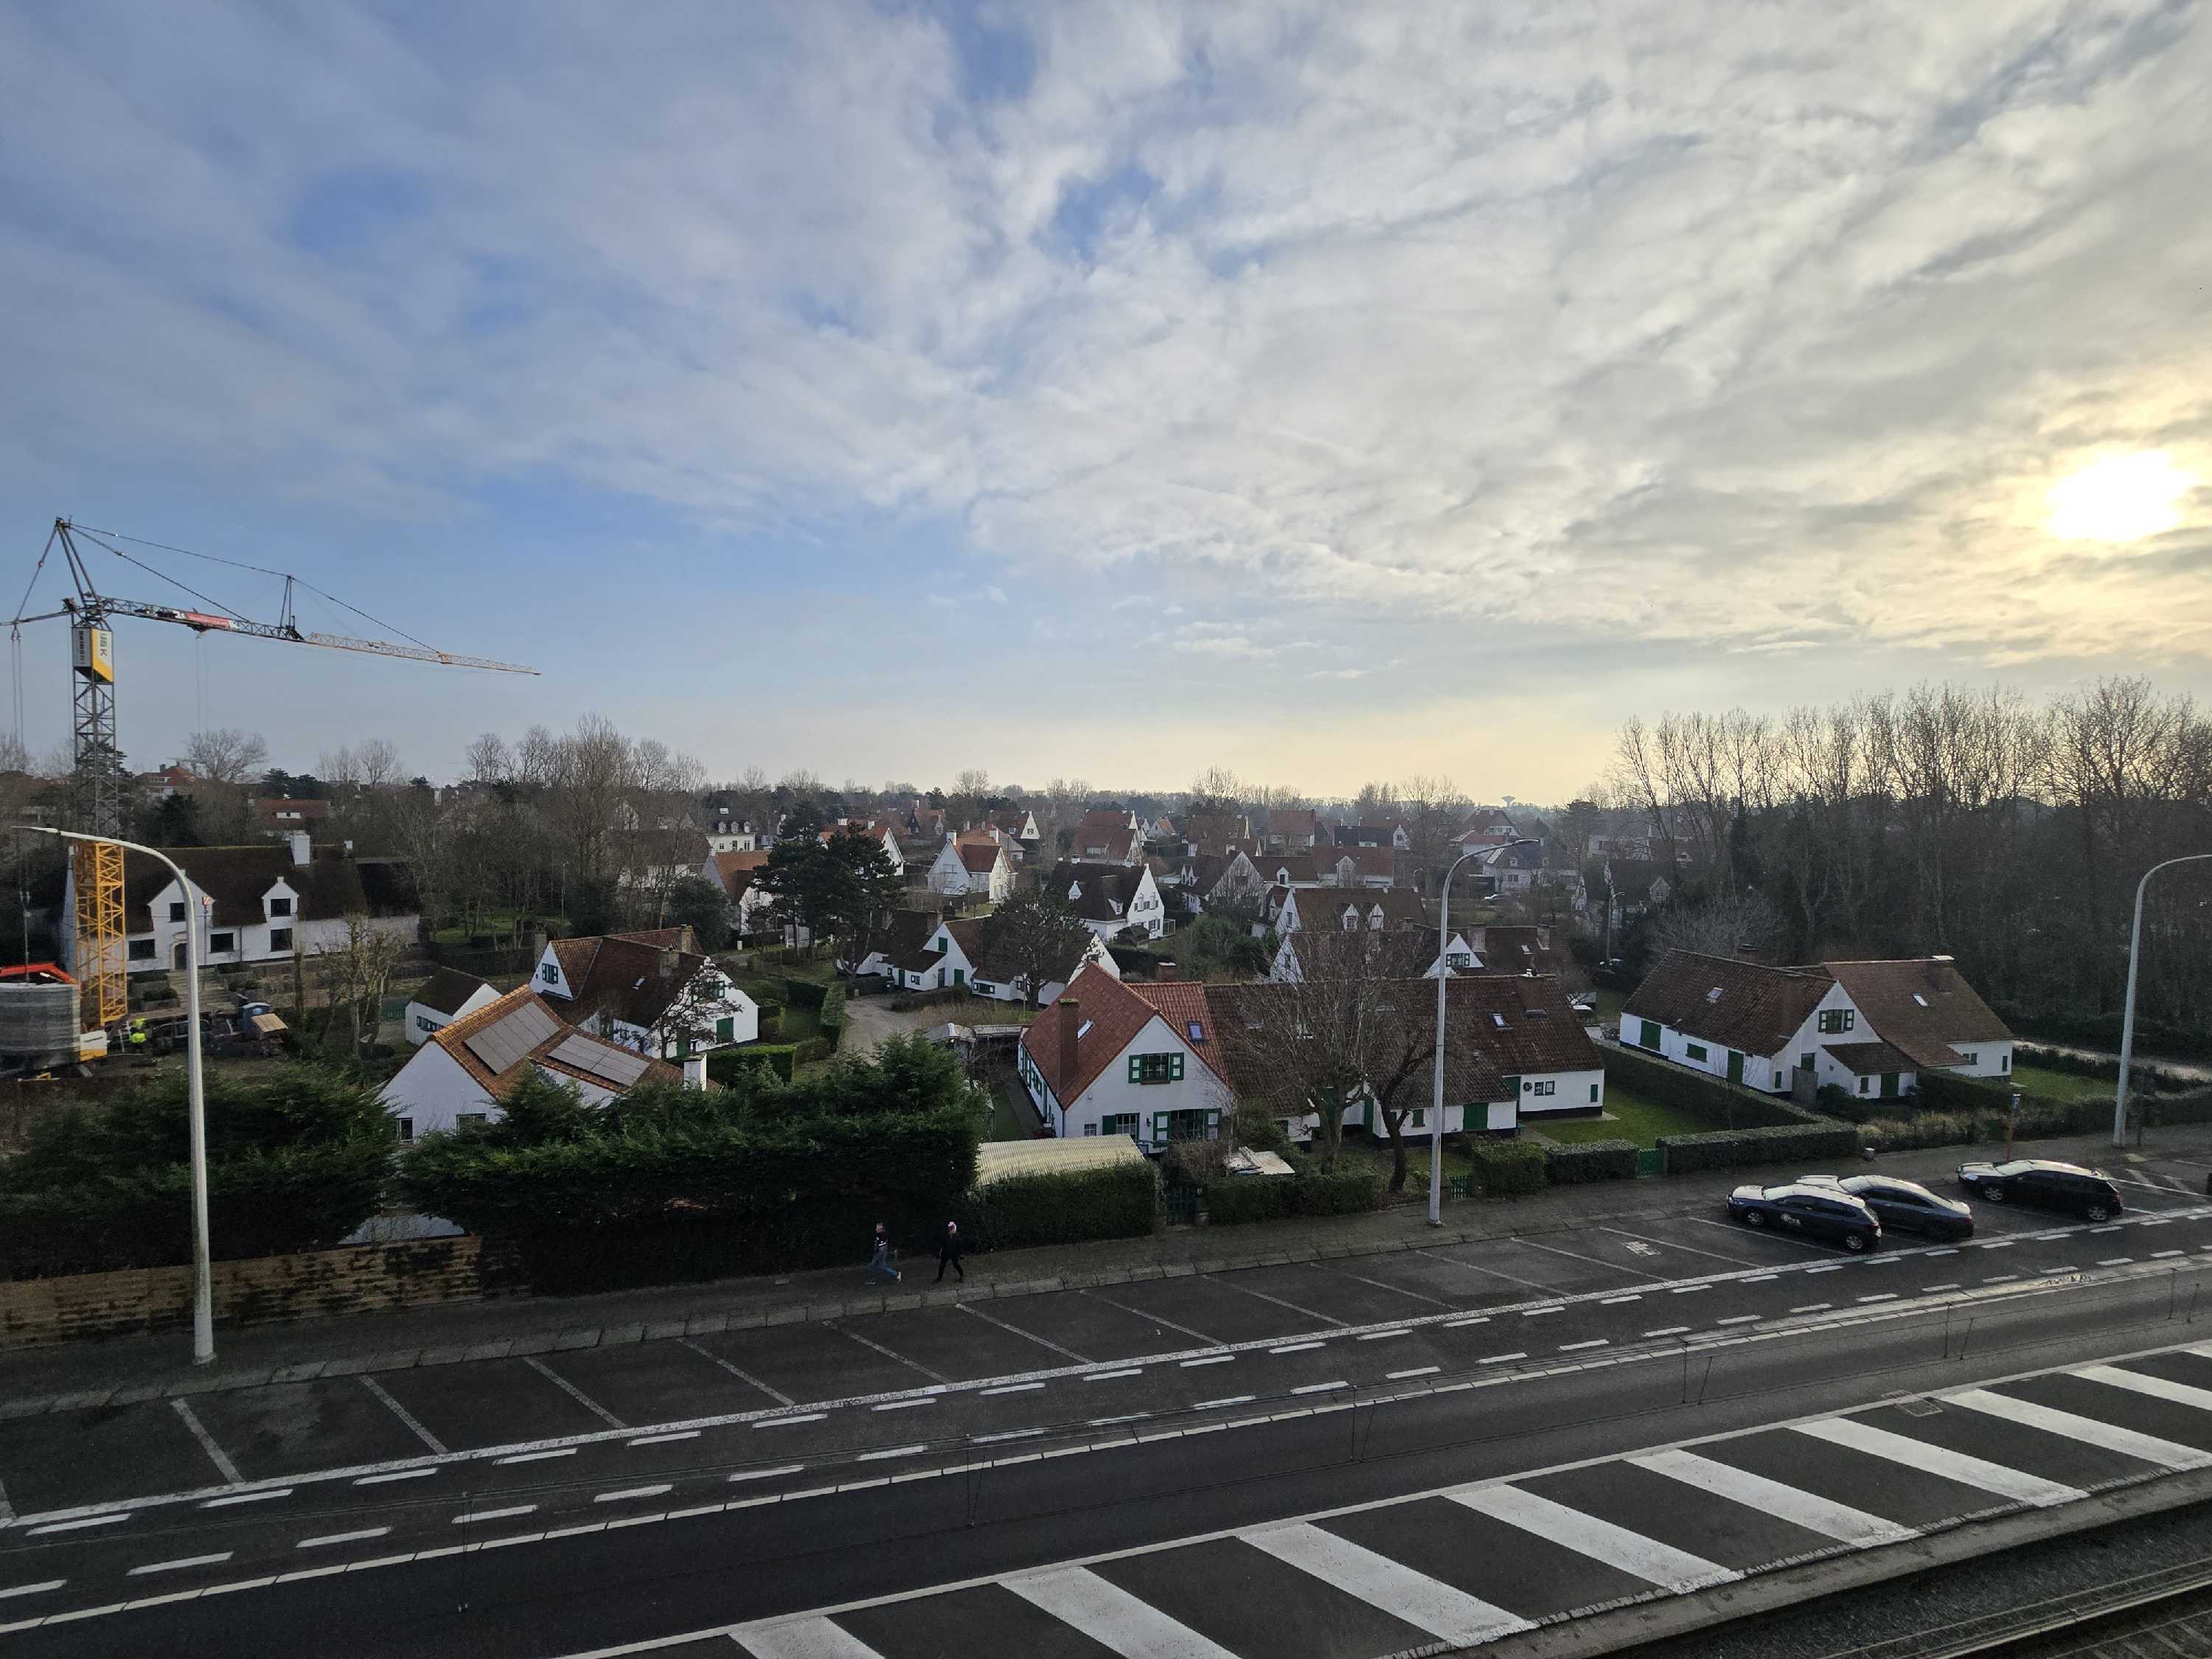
<box><xmin>708</xmin><ymin>1343</ymin><xmax>2212</xmax><ymax>1659</ymax></box>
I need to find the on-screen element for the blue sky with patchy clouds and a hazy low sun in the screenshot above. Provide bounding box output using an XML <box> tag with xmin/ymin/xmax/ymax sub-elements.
<box><xmin>0</xmin><ymin>0</ymin><xmax>2212</xmax><ymax>801</ymax></box>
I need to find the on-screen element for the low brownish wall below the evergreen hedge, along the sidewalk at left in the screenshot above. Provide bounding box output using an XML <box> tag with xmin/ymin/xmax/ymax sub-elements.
<box><xmin>0</xmin><ymin>1237</ymin><xmax>511</xmax><ymax>1349</ymax></box>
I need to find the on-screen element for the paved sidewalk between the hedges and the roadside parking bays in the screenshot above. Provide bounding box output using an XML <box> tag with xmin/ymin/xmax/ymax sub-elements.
<box><xmin>0</xmin><ymin>1126</ymin><xmax>2212</xmax><ymax>1418</ymax></box>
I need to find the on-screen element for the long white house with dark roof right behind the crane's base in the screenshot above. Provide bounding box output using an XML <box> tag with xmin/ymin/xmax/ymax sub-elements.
<box><xmin>60</xmin><ymin>830</ymin><xmax>420</xmax><ymax>973</ymax></box>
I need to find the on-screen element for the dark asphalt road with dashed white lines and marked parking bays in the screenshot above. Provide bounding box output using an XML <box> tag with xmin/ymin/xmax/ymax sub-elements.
<box><xmin>13</xmin><ymin>1188</ymin><xmax>2212</xmax><ymax>1659</ymax></box>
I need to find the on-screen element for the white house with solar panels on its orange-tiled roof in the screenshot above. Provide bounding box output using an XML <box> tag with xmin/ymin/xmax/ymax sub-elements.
<box><xmin>383</xmin><ymin>984</ymin><xmax>706</xmax><ymax>1141</ymax></box>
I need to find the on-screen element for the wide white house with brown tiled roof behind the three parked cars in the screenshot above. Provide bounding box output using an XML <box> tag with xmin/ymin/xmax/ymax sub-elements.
<box><xmin>1621</xmin><ymin>951</ymin><xmax>2013</xmax><ymax>1099</ymax></box>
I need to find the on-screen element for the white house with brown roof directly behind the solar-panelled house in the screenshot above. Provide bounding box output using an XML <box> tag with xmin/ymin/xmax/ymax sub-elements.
<box><xmin>531</xmin><ymin>927</ymin><xmax>761</xmax><ymax>1060</ymax></box>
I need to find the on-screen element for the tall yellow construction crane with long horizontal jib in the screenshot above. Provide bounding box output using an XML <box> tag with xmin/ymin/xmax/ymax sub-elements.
<box><xmin>9</xmin><ymin>518</ymin><xmax>538</xmax><ymax>1029</ymax></box>
